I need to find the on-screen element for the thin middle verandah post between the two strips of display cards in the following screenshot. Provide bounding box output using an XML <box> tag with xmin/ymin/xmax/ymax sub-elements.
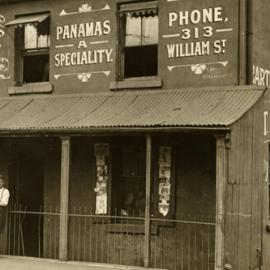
<box><xmin>144</xmin><ymin>134</ymin><xmax>152</xmax><ymax>267</ymax></box>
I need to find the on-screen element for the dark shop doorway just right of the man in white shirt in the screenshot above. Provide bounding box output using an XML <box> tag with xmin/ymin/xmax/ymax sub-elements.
<box><xmin>8</xmin><ymin>146</ymin><xmax>44</xmax><ymax>257</ymax></box>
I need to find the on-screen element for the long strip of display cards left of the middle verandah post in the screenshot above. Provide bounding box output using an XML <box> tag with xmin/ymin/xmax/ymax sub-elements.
<box><xmin>94</xmin><ymin>144</ymin><xmax>109</xmax><ymax>214</ymax></box>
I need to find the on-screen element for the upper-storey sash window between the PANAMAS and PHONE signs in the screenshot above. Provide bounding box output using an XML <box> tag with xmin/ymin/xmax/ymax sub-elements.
<box><xmin>120</xmin><ymin>1</ymin><xmax>158</xmax><ymax>78</ymax></box>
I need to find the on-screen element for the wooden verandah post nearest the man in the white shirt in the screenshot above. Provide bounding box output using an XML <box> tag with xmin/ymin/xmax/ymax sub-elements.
<box><xmin>59</xmin><ymin>137</ymin><xmax>70</xmax><ymax>261</ymax></box>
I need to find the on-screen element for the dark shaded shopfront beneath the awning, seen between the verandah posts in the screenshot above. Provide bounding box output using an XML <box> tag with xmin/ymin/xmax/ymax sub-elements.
<box><xmin>0</xmin><ymin>133</ymin><xmax>216</xmax><ymax>269</ymax></box>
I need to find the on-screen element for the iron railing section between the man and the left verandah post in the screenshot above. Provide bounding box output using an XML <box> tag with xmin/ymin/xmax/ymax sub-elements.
<box><xmin>1</xmin><ymin>205</ymin><xmax>60</xmax><ymax>259</ymax></box>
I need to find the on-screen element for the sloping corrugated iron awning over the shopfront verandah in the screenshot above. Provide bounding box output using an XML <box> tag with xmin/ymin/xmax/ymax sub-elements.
<box><xmin>0</xmin><ymin>86</ymin><xmax>264</xmax><ymax>132</ymax></box>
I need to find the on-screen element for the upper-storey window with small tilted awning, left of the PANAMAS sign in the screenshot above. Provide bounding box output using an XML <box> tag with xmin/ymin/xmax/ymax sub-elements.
<box><xmin>7</xmin><ymin>13</ymin><xmax>50</xmax><ymax>84</ymax></box>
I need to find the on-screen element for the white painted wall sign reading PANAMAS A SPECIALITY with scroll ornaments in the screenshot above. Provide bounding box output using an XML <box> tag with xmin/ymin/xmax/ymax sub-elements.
<box><xmin>54</xmin><ymin>4</ymin><xmax>113</xmax><ymax>82</ymax></box>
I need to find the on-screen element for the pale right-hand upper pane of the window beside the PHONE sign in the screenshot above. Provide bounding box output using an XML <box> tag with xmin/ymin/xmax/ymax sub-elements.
<box><xmin>142</xmin><ymin>16</ymin><xmax>158</xmax><ymax>45</ymax></box>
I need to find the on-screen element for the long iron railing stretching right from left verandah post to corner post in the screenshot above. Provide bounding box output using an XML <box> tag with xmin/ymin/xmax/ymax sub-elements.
<box><xmin>69</xmin><ymin>207</ymin><xmax>215</xmax><ymax>270</ymax></box>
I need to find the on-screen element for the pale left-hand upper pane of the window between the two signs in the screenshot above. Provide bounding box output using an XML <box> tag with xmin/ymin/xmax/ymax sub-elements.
<box><xmin>125</xmin><ymin>14</ymin><xmax>142</xmax><ymax>46</ymax></box>
